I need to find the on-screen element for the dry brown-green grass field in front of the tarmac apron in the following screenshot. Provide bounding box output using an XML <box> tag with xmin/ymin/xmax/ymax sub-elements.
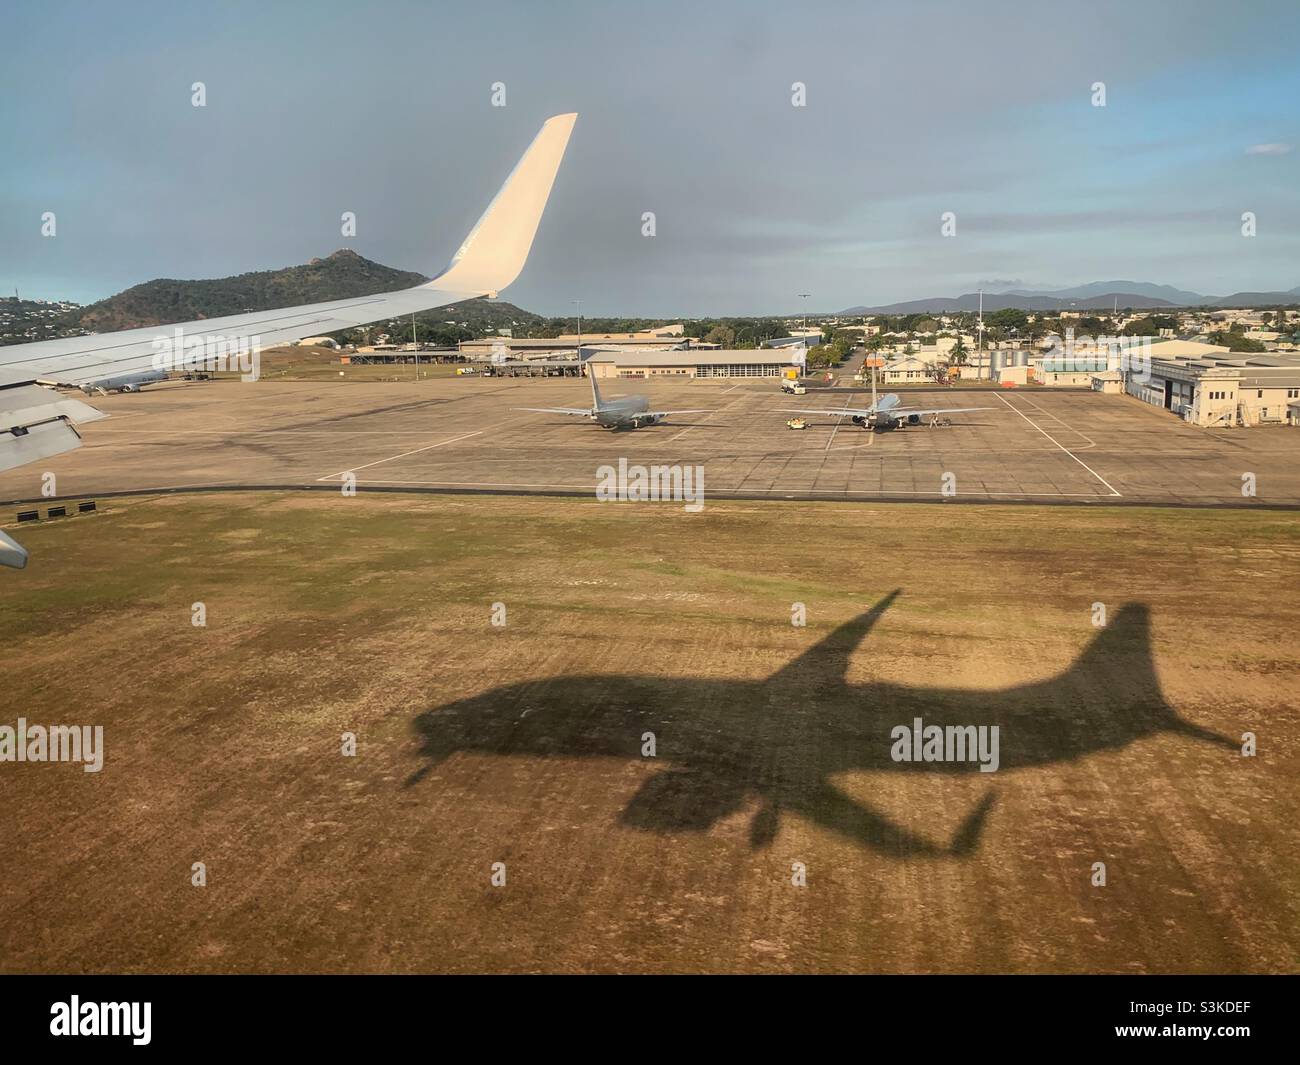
<box><xmin>0</xmin><ymin>493</ymin><xmax>1300</xmax><ymax>973</ymax></box>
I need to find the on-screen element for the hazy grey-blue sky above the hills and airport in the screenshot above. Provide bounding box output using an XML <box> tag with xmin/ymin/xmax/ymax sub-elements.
<box><xmin>0</xmin><ymin>0</ymin><xmax>1300</xmax><ymax>317</ymax></box>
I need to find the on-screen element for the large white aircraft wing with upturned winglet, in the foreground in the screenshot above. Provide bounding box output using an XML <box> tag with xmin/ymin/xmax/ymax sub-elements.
<box><xmin>0</xmin><ymin>114</ymin><xmax>577</xmax><ymax>566</ymax></box>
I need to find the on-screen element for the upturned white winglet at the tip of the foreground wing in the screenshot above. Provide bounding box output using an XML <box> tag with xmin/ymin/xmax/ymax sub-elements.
<box><xmin>425</xmin><ymin>114</ymin><xmax>577</xmax><ymax>295</ymax></box>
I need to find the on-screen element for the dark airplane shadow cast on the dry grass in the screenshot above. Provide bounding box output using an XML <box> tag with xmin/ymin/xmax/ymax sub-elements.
<box><xmin>406</xmin><ymin>592</ymin><xmax>1238</xmax><ymax>858</ymax></box>
